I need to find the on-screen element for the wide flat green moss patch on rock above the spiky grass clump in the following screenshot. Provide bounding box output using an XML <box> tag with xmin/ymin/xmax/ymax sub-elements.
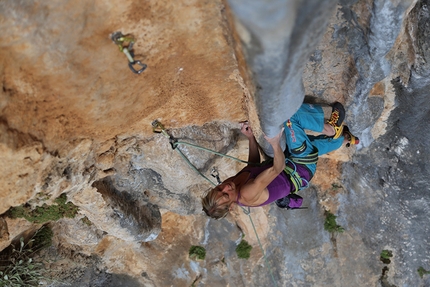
<box><xmin>7</xmin><ymin>193</ymin><xmax>78</xmax><ymax>223</ymax></box>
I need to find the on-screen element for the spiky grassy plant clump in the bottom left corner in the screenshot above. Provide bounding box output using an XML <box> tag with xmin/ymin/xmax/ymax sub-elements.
<box><xmin>0</xmin><ymin>227</ymin><xmax>52</xmax><ymax>287</ymax></box>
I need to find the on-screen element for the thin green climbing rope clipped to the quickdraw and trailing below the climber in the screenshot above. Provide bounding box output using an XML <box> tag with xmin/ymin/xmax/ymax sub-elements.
<box><xmin>152</xmin><ymin>120</ymin><xmax>278</xmax><ymax>286</ymax></box>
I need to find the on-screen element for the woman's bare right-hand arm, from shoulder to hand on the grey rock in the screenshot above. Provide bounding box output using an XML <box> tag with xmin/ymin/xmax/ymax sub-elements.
<box><xmin>241</xmin><ymin>129</ymin><xmax>285</xmax><ymax>205</ymax></box>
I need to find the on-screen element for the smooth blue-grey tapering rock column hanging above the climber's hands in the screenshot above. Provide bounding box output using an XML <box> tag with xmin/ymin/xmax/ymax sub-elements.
<box><xmin>229</xmin><ymin>0</ymin><xmax>336</xmax><ymax>141</ymax></box>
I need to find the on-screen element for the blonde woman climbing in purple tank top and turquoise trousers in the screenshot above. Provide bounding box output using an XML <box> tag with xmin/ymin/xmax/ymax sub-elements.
<box><xmin>202</xmin><ymin>102</ymin><xmax>359</xmax><ymax>219</ymax></box>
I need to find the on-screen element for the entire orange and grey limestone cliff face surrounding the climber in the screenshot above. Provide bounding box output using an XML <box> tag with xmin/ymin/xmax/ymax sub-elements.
<box><xmin>0</xmin><ymin>0</ymin><xmax>430</xmax><ymax>287</ymax></box>
